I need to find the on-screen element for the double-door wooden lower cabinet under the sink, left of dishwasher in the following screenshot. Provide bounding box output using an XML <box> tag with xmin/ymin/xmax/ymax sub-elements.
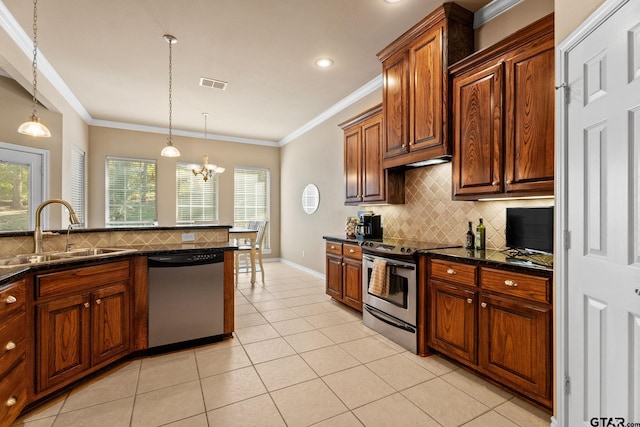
<box><xmin>35</xmin><ymin>260</ymin><xmax>131</xmax><ymax>396</ymax></box>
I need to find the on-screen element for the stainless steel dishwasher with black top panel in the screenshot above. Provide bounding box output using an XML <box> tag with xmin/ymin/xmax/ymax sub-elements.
<box><xmin>148</xmin><ymin>250</ymin><xmax>224</xmax><ymax>348</ymax></box>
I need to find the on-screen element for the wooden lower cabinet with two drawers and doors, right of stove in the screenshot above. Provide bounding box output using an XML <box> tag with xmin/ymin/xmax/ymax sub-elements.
<box><xmin>427</xmin><ymin>258</ymin><xmax>553</xmax><ymax>410</ymax></box>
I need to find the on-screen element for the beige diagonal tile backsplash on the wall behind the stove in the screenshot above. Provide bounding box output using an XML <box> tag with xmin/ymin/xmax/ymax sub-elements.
<box><xmin>376</xmin><ymin>163</ymin><xmax>554</xmax><ymax>249</ymax></box>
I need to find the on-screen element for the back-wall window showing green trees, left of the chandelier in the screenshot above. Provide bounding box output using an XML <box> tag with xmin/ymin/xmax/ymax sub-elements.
<box><xmin>105</xmin><ymin>157</ymin><xmax>157</xmax><ymax>227</ymax></box>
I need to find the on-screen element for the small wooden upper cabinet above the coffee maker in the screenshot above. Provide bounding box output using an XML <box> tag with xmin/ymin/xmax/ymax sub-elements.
<box><xmin>339</xmin><ymin>105</ymin><xmax>404</xmax><ymax>204</ymax></box>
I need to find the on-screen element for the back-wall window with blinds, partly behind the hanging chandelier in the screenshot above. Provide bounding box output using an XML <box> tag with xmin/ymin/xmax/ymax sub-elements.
<box><xmin>176</xmin><ymin>163</ymin><xmax>218</xmax><ymax>223</ymax></box>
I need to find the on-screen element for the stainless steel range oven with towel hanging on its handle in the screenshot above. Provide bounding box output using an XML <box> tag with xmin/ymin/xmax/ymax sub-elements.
<box><xmin>362</xmin><ymin>238</ymin><xmax>460</xmax><ymax>353</ymax></box>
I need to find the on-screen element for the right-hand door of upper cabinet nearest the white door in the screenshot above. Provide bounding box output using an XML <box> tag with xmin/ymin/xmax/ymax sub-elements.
<box><xmin>504</xmin><ymin>40</ymin><xmax>555</xmax><ymax>194</ymax></box>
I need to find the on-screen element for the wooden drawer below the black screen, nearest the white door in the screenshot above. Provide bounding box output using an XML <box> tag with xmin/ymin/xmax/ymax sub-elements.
<box><xmin>480</xmin><ymin>268</ymin><xmax>551</xmax><ymax>303</ymax></box>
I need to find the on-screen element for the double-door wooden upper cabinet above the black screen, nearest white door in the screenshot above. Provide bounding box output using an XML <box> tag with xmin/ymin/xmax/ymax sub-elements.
<box><xmin>449</xmin><ymin>14</ymin><xmax>555</xmax><ymax>200</ymax></box>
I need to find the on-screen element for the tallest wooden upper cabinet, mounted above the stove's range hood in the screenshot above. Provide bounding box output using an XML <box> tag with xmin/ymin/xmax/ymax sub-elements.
<box><xmin>378</xmin><ymin>3</ymin><xmax>473</xmax><ymax>168</ymax></box>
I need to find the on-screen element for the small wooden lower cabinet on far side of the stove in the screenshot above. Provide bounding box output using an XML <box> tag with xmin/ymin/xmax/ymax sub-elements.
<box><xmin>326</xmin><ymin>241</ymin><xmax>362</xmax><ymax>311</ymax></box>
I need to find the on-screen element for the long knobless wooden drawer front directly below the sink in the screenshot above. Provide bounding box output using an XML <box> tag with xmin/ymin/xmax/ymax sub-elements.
<box><xmin>36</xmin><ymin>260</ymin><xmax>129</xmax><ymax>298</ymax></box>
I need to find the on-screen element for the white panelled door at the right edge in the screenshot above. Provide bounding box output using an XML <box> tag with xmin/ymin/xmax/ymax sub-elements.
<box><xmin>558</xmin><ymin>0</ymin><xmax>640</xmax><ymax>426</ymax></box>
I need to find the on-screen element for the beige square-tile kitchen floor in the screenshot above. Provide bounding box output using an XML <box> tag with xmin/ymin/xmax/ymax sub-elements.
<box><xmin>14</xmin><ymin>263</ymin><xmax>550</xmax><ymax>427</ymax></box>
